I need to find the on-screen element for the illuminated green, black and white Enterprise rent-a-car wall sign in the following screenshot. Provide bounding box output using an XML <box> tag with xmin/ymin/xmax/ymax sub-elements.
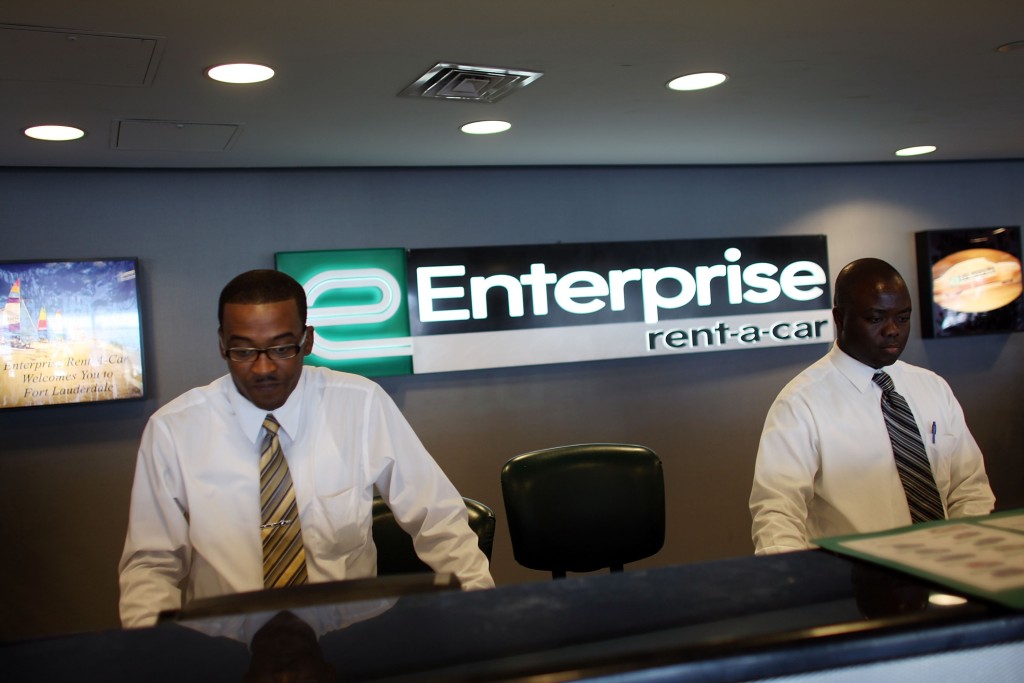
<box><xmin>276</xmin><ymin>236</ymin><xmax>835</xmax><ymax>376</ymax></box>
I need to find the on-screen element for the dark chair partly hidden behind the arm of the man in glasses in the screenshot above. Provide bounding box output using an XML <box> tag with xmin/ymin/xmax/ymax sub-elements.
<box><xmin>373</xmin><ymin>496</ymin><xmax>496</xmax><ymax>577</ymax></box>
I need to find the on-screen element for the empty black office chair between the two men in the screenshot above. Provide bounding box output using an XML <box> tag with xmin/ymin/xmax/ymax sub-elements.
<box><xmin>502</xmin><ymin>443</ymin><xmax>665</xmax><ymax>579</ymax></box>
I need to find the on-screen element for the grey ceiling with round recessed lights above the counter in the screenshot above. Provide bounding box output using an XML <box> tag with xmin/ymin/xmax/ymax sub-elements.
<box><xmin>0</xmin><ymin>0</ymin><xmax>1024</xmax><ymax>168</ymax></box>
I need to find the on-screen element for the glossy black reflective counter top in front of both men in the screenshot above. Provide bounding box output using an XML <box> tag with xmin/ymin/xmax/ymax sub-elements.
<box><xmin>0</xmin><ymin>550</ymin><xmax>1024</xmax><ymax>682</ymax></box>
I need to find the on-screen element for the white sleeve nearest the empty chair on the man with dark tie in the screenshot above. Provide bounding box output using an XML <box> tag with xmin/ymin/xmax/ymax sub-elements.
<box><xmin>750</xmin><ymin>389</ymin><xmax>820</xmax><ymax>555</ymax></box>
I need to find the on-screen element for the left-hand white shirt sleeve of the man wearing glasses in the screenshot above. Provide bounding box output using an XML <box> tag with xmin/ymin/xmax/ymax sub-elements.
<box><xmin>119</xmin><ymin>421</ymin><xmax>190</xmax><ymax>628</ymax></box>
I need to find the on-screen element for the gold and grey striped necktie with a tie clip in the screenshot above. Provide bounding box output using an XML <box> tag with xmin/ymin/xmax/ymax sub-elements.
<box><xmin>259</xmin><ymin>413</ymin><xmax>306</xmax><ymax>588</ymax></box>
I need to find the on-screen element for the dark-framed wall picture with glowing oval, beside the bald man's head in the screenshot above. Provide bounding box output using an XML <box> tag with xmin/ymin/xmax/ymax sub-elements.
<box><xmin>914</xmin><ymin>226</ymin><xmax>1024</xmax><ymax>338</ymax></box>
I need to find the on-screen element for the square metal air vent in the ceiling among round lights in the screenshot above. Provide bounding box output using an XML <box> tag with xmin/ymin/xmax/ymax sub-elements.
<box><xmin>398</xmin><ymin>61</ymin><xmax>544</xmax><ymax>102</ymax></box>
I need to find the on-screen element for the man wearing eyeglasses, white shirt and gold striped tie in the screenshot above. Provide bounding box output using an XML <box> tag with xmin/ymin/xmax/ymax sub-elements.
<box><xmin>120</xmin><ymin>270</ymin><xmax>494</xmax><ymax>627</ymax></box>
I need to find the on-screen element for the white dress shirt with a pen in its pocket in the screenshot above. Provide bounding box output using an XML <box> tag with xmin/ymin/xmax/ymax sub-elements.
<box><xmin>750</xmin><ymin>344</ymin><xmax>995</xmax><ymax>555</ymax></box>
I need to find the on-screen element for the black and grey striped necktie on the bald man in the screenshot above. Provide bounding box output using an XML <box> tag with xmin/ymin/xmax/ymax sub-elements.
<box><xmin>871</xmin><ymin>370</ymin><xmax>946</xmax><ymax>524</ymax></box>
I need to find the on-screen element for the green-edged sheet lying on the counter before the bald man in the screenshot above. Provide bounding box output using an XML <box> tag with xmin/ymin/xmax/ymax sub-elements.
<box><xmin>814</xmin><ymin>510</ymin><xmax>1024</xmax><ymax>609</ymax></box>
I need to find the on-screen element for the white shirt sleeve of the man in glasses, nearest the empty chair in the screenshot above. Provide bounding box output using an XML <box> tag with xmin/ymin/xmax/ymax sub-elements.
<box><xmin>369</xmin><ymin>389</ymin><xmax>495</xmax><ymax>590</ymax></box>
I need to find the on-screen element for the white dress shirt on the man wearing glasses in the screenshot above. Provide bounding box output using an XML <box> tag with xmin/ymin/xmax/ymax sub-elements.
<box><xmin>120</xmin><ymin>367</ymin><xmax>494</xmax><ymax>627</ymax></box>
